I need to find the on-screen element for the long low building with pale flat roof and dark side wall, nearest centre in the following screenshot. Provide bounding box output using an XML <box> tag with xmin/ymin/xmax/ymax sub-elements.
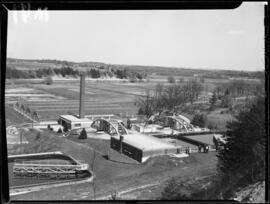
<box><xmin>111</xmin><ymin>133</ymin><xmax>187</xmax><ymax>162</ymax></box>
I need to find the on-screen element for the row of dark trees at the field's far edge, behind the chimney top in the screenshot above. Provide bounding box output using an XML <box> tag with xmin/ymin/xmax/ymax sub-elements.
<box><xmin>6</xmin><ymin>66</ymin><xmax>146</xmax><ymax>80</ymax></box>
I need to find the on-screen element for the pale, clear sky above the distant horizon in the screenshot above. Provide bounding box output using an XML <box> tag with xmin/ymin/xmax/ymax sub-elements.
<box><xmin>7</xmin><ymin>2</ymin><xmax>264</xmax><ymax>71</ymax></box>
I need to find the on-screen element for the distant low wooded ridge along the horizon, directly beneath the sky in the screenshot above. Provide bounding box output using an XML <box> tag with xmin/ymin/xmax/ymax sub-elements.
<box><xmin>7</xmin><ymin>58</ymin><xmax>265</xmax><ymax>80</ymax></box>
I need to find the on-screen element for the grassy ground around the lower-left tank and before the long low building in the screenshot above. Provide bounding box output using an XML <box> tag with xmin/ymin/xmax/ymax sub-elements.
<box><xmin>10</xmin><ymin>128</ymin><xmax>217</xmax><ymax>200</ymax></box>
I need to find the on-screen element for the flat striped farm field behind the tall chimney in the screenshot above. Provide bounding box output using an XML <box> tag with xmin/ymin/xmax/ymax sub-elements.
<box><xmin>6</xmin><ymin>80</ymin><xmax>158</xmax><ymax>120</ymax></box>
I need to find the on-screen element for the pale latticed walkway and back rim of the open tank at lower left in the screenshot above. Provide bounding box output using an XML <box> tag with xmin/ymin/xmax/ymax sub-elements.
<box><xmin>8</xmin><ymin>152</ymin><xmax>90</xmax><ymax>179</ymax></box>
